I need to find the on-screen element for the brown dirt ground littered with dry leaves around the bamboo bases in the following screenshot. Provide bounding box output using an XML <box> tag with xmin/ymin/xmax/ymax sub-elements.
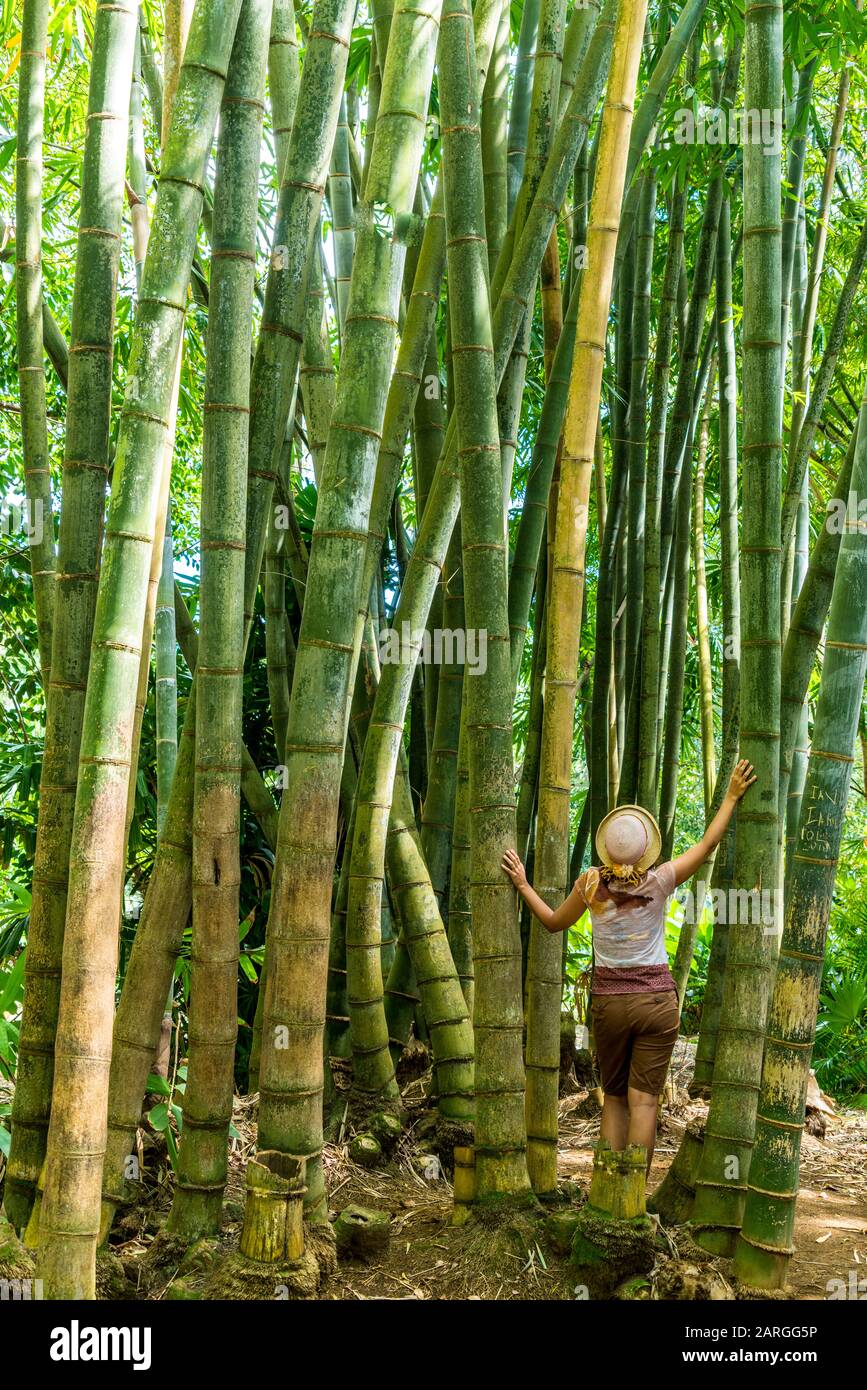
<box><xmin>94</xmin><ymin>1050</ymin><xmax>867</xmax><ymax>1300</ymax></box>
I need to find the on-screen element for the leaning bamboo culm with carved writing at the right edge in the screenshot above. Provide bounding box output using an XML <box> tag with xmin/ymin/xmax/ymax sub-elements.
<box><xmin>734</xmin><ymin>392</ymin><xmax>867</xmax><ymax>1289</ymax></box>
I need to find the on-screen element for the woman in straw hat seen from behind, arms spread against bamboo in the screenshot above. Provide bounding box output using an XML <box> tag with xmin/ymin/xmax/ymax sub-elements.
<box><xmin>502</xmin><ymin>759</ymin><xmax>756</xmax><ymax>1172</ymax></box>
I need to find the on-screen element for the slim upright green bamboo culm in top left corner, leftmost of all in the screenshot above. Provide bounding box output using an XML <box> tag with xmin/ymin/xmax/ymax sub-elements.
<box><xmin>15</xmin><ymin>0</ymin><xmax>54</xmax><ymax>691</ymax></box>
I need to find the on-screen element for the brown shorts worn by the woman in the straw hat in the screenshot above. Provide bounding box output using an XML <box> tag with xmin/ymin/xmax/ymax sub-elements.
<box><xmin>591</xmin><ymin>990</ymin><xmax>679</xmax><ymax>1095</ymax></box>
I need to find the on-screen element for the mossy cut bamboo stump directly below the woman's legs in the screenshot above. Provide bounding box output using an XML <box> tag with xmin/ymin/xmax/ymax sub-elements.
<box><xmin>571</xmin><ymin>1140</ymin><xmax>654</xmax><ymax>1298</ymax></box>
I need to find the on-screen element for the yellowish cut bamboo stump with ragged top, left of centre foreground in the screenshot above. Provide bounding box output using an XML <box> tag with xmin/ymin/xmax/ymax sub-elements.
<box><xmin>240</xmin><ymin>1150</ymin><xmax>307</xmax><ymax>1265</ymax></box>
